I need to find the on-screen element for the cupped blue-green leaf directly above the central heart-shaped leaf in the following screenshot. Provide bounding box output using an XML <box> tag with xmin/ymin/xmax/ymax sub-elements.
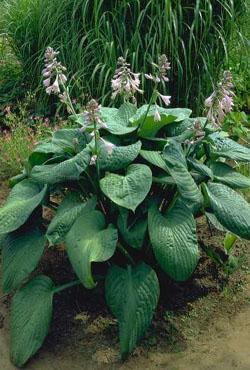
<box><xmin>98</xmin><ymin>141</ymin><xmax>141</xmax><ymax>171</ymax></box>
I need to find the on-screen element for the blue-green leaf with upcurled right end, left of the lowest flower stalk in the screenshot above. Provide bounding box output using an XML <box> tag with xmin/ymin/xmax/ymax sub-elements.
<box><xmin>31</xmin><ymin>148</ymin><xmax>91</xmax><ymax>184</ymax></box>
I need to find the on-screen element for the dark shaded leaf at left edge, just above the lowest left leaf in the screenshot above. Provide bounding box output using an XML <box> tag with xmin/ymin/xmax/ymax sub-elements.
<box><xmin>2</xmin><ymin>227</ymin><xmax>46</xmax><ymax>293</ymax></box>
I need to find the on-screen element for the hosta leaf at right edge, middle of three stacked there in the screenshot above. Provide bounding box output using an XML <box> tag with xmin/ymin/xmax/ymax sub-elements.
<box><xmin>211</xmin><ymin>162</ymin><xmax>250</xmax><ymax>189</ymax></box>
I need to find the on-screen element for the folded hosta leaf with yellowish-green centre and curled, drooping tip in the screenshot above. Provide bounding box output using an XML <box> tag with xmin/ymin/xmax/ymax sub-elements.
<box><xmin>66</xmin><ymin>211</ymin><xmax>118</xmax><ymax>289</ymax></box>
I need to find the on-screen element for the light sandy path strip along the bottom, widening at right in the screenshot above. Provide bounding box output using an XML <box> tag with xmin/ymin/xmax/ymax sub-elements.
<box><xmin>0</xmin><ymin>294</ymin><xmax>250</xmax><ymax>370</ymax></box>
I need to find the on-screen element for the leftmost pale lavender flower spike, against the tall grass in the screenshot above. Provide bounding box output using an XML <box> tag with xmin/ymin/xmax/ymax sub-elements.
<box><xmin>42</xmin><ymin>47</ymin><xmax>67</xmax><ymax>96</ymax></box>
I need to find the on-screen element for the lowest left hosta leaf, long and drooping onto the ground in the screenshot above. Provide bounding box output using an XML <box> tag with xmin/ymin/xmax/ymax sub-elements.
<box><xmin>10</xmin><ymin>275</ymin><xmax>54</xmax><ymax>367</ymax></box>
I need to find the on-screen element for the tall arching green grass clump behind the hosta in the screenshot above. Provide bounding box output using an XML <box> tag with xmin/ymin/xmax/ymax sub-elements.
<box><xmin>3</xmin><ymin>0</ymin><xmax>247</xmax><ymax>112</ymax></box>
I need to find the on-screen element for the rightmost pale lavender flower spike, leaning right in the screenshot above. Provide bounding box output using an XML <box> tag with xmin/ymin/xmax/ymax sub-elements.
<box><xmin>205</xmin><ymin>71</ymin><xmax>235</xmax><ymax>128</ymax></box>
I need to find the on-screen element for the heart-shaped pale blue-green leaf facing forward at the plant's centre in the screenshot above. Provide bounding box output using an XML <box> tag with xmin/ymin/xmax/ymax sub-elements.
<box><xmin>100</xmin><ymin>164</ymin><xmax>152</xmax><ymax>211</ymax></box>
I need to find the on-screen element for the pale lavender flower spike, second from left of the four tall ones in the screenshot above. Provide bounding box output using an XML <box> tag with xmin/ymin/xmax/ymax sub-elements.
<box><xmin>111</xmin><ymin>57</ymin><xmax>143</xmax><ymax>102</ymax></box>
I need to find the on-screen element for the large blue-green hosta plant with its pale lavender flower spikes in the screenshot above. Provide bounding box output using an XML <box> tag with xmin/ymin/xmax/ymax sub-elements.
<box><xmin>0</xmin><ymin>48</ymin><xmax>250</xmax><ymax>366</ymax></box>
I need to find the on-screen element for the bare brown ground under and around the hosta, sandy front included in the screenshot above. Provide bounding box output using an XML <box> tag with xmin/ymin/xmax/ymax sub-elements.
<box><xmin>0</xmin><ymin>180</ymin><xmax>250</xmax><ymax>370</ymax></box>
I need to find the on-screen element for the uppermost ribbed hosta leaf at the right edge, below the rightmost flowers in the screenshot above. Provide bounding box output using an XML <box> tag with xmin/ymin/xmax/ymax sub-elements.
<box><xmin>209</xmin><ymin>133</ymin><xmax>250</xmax><ymax>162</ymax></box>
